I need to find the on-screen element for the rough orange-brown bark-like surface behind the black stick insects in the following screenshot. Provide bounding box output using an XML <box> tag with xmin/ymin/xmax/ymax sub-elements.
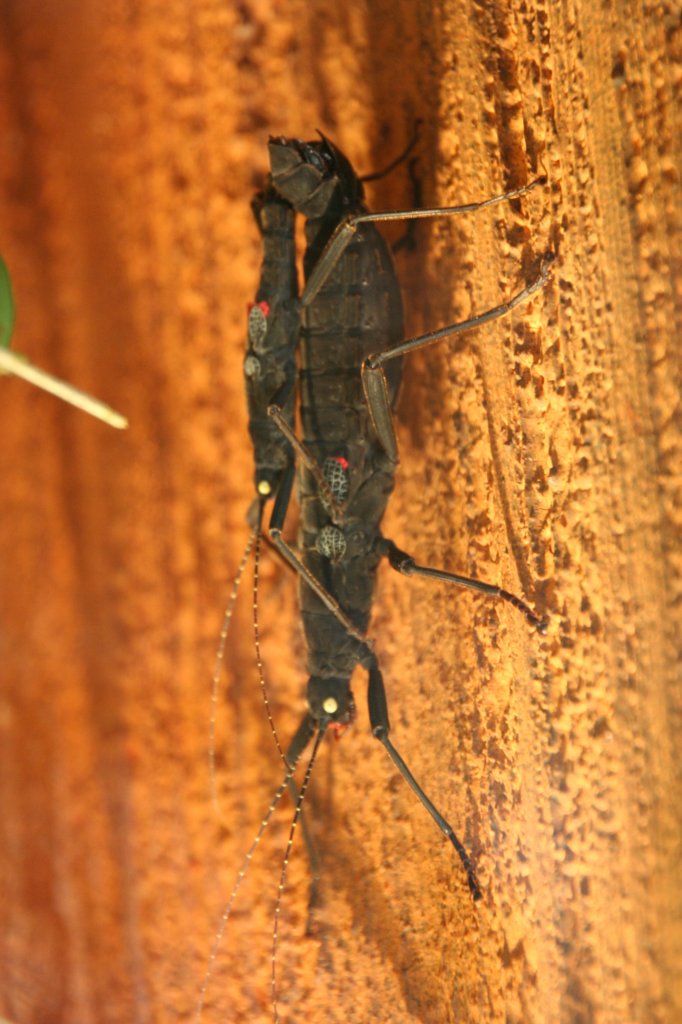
<box><xmin>0</xmin><ymin>0</ymin><xmax>682</xmax><ymax>1024</ymax></box>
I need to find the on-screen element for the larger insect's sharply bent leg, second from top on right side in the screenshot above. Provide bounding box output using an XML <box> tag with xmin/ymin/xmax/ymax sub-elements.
<box><xmin>363</xmin><ymin>254</ymin><xmax>553</xmax><ymax>462</ymax></box>
